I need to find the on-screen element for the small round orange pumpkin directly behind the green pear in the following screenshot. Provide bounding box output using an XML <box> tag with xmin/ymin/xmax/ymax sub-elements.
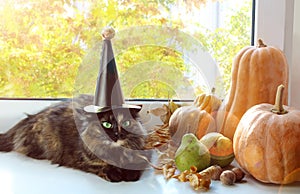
<box><xmin>169</xmin><ymin>106</ymin><xmax>216</xmax><ymax>144</ymax></box>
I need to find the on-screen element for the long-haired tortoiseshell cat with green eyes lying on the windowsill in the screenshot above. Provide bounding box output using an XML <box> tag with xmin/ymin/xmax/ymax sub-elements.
<box><xmin>0</xmin><ymin>95</ymin><xmax>152</xmax><ymax>182</ymax></box>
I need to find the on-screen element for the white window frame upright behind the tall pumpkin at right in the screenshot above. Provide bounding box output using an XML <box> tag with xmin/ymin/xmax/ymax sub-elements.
<box><xmin>255</xmin><ymin>0</ymin><xmax>300</xmax><ymax>109</ymax></box>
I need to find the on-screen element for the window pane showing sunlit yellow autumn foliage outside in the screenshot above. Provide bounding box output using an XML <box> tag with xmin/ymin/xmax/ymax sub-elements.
<box><xmin>0</xmin><ymin>0</ymin><xmax>252</xmax><ymax>100</ymax></box>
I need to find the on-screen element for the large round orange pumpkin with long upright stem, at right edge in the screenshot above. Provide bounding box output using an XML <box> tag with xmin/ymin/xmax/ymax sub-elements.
<box><xmin>233</xmin><ymin>85</ymin><xmax>300</xmax><ymax>184</ymax></box>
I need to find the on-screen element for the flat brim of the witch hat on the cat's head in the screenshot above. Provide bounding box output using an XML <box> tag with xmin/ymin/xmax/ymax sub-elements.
<box><xmin>84</xmin><ymin>104</ymin><xmax>142</xmax><ymax>113</ymax></box>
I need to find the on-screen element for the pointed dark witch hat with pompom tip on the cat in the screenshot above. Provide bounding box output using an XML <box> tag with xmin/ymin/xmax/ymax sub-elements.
<box><xmin>84</xmin><ymin>27</ymin><xmax>141</xmax><ymax>113</ymax></box>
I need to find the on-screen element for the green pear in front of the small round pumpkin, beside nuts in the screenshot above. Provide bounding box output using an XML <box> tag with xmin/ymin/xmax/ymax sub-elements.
<box><xmin>175</xmin><ymin>133</ymin><xmax>210</xmax><ymax>172</ymax></box>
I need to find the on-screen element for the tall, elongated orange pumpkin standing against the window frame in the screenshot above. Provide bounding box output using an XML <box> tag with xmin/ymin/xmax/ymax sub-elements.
<box><xmin>217</xmin><ymin>40</ymin><xmax>289</xmax><ymax>139</ymax></box>
